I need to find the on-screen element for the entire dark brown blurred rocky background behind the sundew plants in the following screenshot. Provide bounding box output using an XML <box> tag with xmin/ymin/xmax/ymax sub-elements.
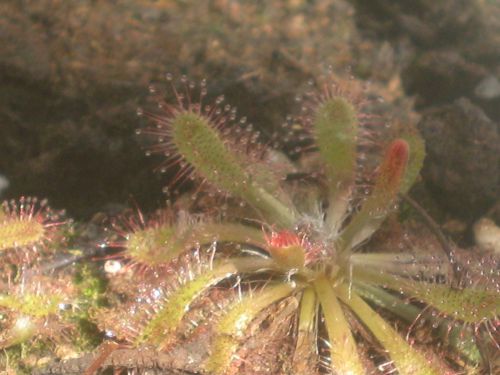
<box><xmin>0</xmin><ymin>0</ymin><xmax>500</xmax><ymax>241</ymax></box>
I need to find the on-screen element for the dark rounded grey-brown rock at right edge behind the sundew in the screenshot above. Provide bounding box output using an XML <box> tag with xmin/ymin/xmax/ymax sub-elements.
<box><xmin>418</xmin><ymin>99</ymin><xmax>500</xmax><ymax>221</ymax></box>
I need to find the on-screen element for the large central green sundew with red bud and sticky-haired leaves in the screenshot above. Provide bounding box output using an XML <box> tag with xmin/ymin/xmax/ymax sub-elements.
<box><xmin>94</xmin><ymin>76</ymin><xmax>499</xmax><ymax>375</ymax></box>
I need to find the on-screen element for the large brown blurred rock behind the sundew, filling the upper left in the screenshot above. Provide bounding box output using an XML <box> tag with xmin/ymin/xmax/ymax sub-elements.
<box><xmin>0</xmin><ymin>0</ymin><xmax>362</xmax><ymax>219</ymax></box>
